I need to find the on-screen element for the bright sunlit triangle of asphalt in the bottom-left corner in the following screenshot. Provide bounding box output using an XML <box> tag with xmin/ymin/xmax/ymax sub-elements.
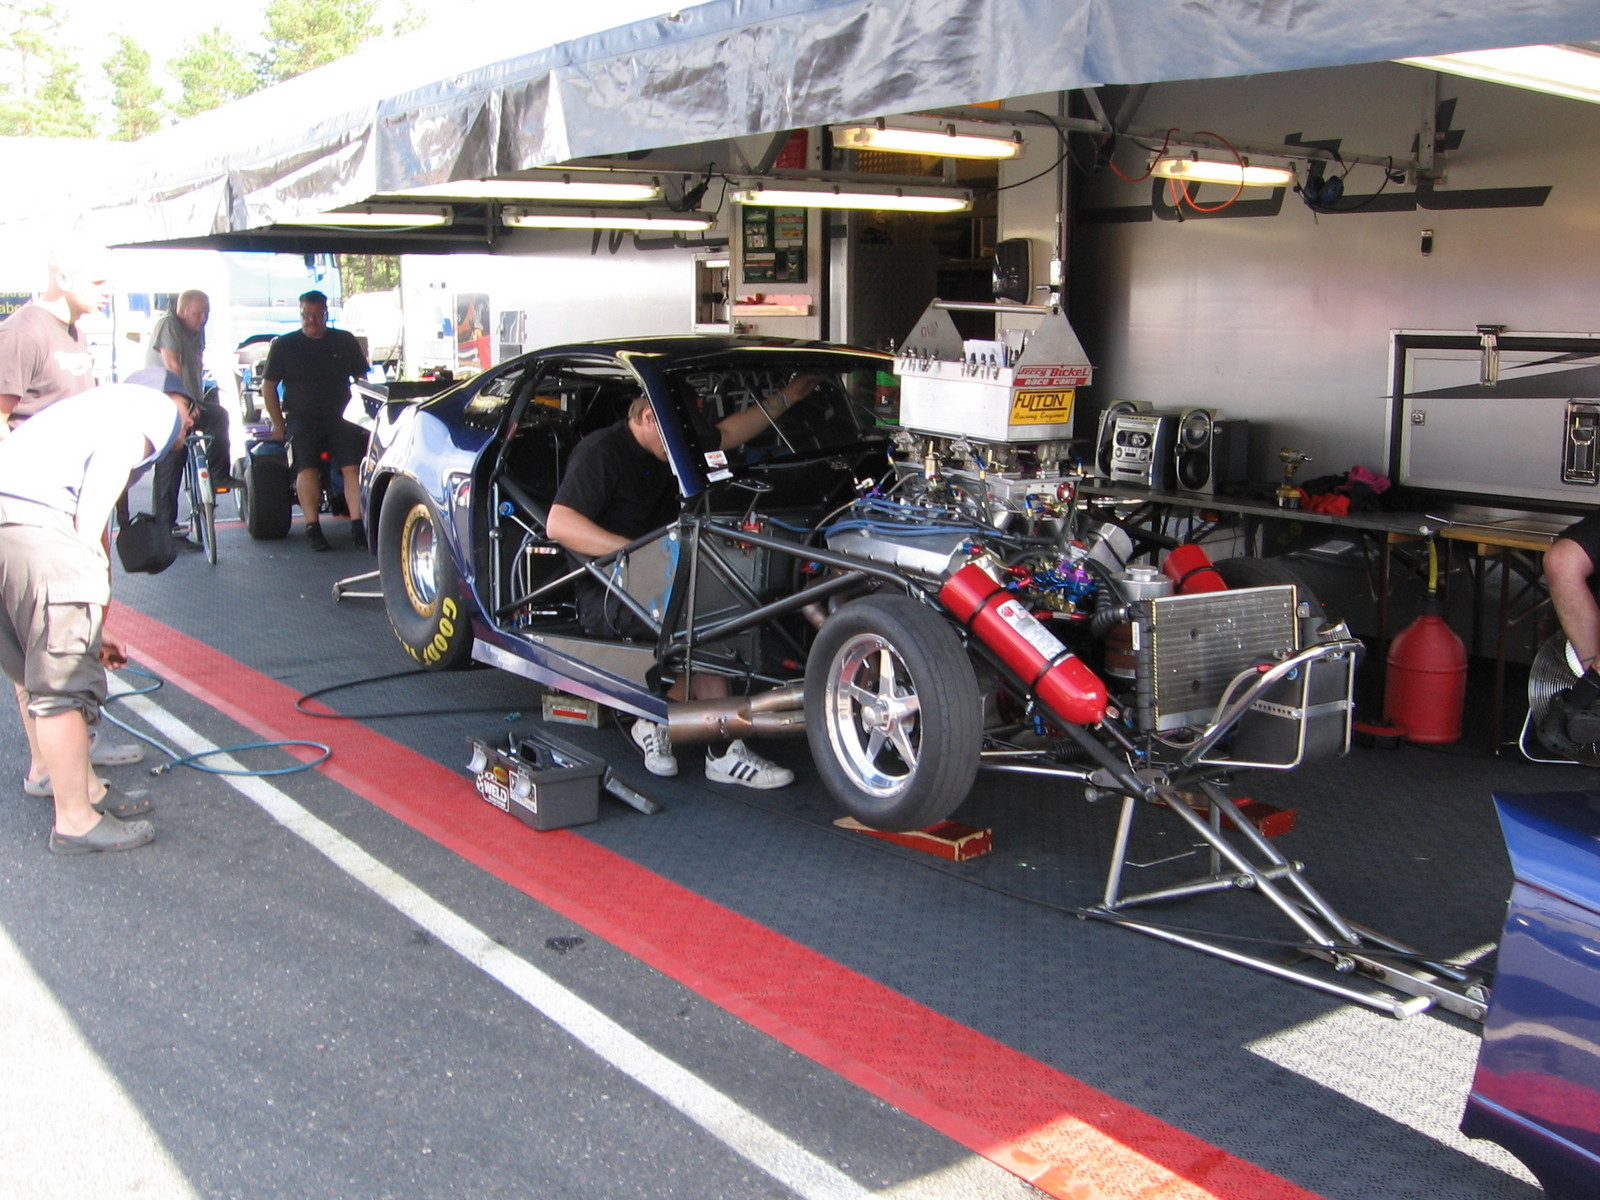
<box><xmin>0</xmin><ymin>930</ymin><xmax>198</xmax><ymax>1200</ymax></box>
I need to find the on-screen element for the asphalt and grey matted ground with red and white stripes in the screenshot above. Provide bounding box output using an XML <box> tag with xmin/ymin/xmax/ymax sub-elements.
<box><xmin>0</xmin><ymin>492</ymin><xmax>1586</xmax><ymax>1200</ymax></box>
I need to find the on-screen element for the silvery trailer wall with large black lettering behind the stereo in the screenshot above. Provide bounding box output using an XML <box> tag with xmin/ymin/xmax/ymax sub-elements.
<box><xmin>1072</xmin><ymin>64</ymin><xmax>1600</xmax><ymax>474</ymax></box>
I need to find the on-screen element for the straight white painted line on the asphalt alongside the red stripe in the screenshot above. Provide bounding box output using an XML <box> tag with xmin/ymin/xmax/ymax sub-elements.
<box><xmin>123</xmin><ymin>696</ymin><xmax>872</xmax><ymax>1200</ymax></box>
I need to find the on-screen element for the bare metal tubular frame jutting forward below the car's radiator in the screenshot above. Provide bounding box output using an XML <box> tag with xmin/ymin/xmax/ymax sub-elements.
<box><xmin>1098</xmin><ymin>782</ymin><xmax>1488</xmax><ymax>1021</ymax></box>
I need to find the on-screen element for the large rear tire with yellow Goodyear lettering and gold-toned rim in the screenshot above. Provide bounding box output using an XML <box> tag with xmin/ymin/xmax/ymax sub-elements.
<box><xmin>378</xmin><ymin>478</ymin><xmax>472</xmax><ymax>670</ymax></box>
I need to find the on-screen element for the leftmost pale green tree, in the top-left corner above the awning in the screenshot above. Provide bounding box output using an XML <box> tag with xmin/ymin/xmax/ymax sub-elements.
<box><xmin>0</xmin><ymin>0</ymin><xmax>94</xmax><ymax>138</ymax></box>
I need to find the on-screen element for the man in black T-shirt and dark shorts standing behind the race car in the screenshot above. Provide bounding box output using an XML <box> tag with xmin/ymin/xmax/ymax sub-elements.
<box><xmin>261</xmin><ymin>291</ymin><xmax>368</xmax><ymax>550</ymax></box>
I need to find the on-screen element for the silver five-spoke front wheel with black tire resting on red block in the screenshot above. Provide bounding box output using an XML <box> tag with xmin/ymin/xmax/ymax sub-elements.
<box><xmin>805</xmin><ymin>595</ymin><xmax>982</xmax><ymax>830</ymax></box>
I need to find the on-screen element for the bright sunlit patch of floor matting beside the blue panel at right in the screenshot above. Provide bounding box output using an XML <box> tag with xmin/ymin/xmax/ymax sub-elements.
<box><xmin>1245</xmin><ymin>1006</ymin><xmax>1534</xmax><ymax>1184</ymax></box>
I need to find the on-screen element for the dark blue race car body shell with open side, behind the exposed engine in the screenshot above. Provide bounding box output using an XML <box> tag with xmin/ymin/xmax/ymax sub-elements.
<box><xmin>362</xmin><ymin>338</ymin><xmax>893</xmax><ymax>720</ymax></box>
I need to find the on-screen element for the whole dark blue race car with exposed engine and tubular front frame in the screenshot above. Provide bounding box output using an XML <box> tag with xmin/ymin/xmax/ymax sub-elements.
<box><xmin>362</xmin><ymin>324</ymin><xmax>1486</xmax><ymax>1019</ymax></box>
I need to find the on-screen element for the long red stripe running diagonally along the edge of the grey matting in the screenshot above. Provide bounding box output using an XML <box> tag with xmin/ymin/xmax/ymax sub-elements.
<box><xmin>112</xmin><ymin>605</ymin><xmax>1318</xmax><ymax>1200</ymax></box>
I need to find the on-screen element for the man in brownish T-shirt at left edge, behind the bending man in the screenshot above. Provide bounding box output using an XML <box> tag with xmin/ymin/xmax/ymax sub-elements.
<box><xmin>0</xmin><ymin>242</ymin><xmax>144</xmax><ymax>797</ymax></box>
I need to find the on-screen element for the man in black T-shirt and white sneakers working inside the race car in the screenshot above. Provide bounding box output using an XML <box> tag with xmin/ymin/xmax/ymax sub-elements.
<box><xmin>546</xmin><ymin>374</ymin><xmax>818</xmax><ymax>787</ymax></box>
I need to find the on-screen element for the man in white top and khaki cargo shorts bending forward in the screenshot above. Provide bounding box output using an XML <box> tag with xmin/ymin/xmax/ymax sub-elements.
<box><xmin>0</xmin><ymin>366</ymin><xmax>194</xmax><ymax>854</ymax></box>
